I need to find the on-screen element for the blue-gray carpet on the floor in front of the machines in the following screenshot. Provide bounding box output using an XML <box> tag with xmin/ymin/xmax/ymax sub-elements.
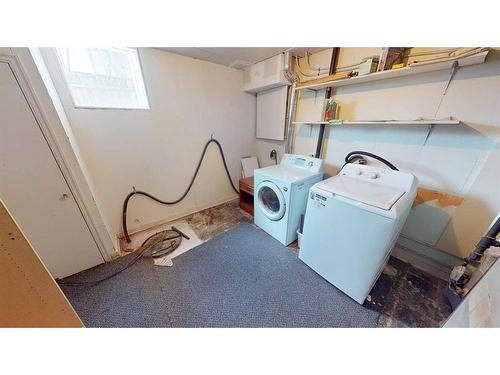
<box><xmin>59</xmin><ymin>223</ymin><xmax>379</xmax><ymax>327</ymax></box>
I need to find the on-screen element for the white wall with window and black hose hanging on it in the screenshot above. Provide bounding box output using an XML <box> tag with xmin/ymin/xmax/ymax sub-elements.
<box><xmin>42</xmin><ymin>48</ymin><xmax>255</xmax><ymax>241</ymax></box>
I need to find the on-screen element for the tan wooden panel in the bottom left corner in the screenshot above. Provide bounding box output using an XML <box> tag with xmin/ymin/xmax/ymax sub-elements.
<box><xmin>0</xmin><ymin>202</ymin><xmax>83</xmax><ymax>327</ymax></box>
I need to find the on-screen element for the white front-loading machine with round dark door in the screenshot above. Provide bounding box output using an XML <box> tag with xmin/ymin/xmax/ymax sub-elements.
<box><xmin>254</xmin><ymin>154</ymin><xmax>325</xmax><ymax>245</ymax></box>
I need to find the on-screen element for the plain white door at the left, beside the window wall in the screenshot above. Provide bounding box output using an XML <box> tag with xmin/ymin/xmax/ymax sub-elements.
<box><xmin>0</xmin><ymin>63</ymin><xmax>104</xmax><ymax>277</ymax></box>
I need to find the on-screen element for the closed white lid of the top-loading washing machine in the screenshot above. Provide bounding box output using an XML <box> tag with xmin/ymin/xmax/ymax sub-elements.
<box><xmin>318</xmin><ymin>175</ymin><xmax>405</xmax><ymax>210</ymax></box>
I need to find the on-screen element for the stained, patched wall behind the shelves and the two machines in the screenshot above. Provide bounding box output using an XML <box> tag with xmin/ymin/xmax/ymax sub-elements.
<box><xmin>257</xmin><ymin>48</ymin><xmax>500</xmax><ymax>257</ymax></box>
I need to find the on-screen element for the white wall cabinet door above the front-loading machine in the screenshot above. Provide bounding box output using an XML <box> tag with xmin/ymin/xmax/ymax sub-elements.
<box><xmin>257</xmin><ymin>86</ymin><xmax>288</xmax><ymax>141</ymax></box>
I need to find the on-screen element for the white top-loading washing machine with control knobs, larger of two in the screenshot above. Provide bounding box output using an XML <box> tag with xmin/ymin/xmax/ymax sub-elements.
<box><xmin>299</xmin><ymin>164</ymin><xmax>418</xmax><ymax>304</ymax></box>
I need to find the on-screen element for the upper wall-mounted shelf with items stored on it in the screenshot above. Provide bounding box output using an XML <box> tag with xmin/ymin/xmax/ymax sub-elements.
<box><xmin>296</xmin><ymin>51</ymin><xmax>488</xmax><ymax>91</ymax></box>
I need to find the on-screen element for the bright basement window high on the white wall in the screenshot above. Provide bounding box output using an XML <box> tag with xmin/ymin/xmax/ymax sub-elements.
<box><xmin>56</xmin><ymin>47</ymin><xmax>149</xmax><ymax>109</ymax></box>
